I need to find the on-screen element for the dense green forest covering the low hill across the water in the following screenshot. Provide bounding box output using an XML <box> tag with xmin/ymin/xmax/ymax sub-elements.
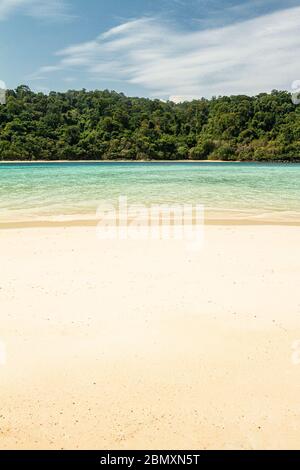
<box><xmin>0</xmin><ymin>86</ymin><xmax>300</xmax><ymax>161</ymax></box>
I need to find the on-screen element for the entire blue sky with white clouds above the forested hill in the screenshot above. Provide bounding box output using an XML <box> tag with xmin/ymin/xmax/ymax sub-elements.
<box><xmin>0</xmin><ymin>0</ymin><xmax>300</xmax><ymax>102</ymax></box>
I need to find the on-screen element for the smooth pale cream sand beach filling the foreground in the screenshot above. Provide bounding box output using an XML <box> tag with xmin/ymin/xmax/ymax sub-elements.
<box><xmin>0</xmin><ymin>225</ymin><xmax>300</xmax><ymax>449</ymax></box>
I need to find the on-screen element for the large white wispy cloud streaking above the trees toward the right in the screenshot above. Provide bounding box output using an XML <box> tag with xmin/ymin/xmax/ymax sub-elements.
<box><xmin>32</xmin><ymin>7</ymin><xmax>300</xmax><ymax>101</ymax></box>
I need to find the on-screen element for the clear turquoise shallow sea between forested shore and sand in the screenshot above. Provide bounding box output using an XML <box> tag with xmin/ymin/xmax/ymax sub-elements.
<box><xmin>0</xmin><ymin>162</ymin><xmax>300</xmax><ymax>224</ymax></box>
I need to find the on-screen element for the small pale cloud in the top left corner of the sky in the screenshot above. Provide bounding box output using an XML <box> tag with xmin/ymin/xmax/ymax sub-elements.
<box><xmin>0</xmin><ymin>0</ymin><xmax>71</xmax><ymax>21</ymax></box>
